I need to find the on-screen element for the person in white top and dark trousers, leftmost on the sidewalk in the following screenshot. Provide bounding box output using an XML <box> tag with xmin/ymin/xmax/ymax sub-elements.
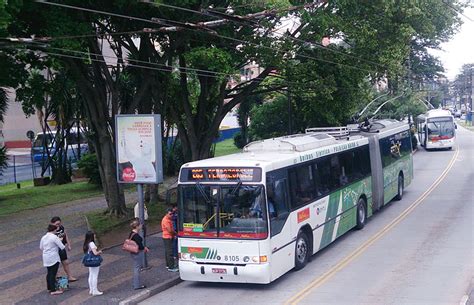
<box><xmin>40</xmin><ymin>224</ymin><xmax>65</xmax><ymax>295</ymax></box>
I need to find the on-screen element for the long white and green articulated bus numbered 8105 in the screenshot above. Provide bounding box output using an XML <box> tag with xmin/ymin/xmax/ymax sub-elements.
<box><xmin>177</xmin><ymin>120</ymin><xmax>413</xmax><ymax>283</ymax></box>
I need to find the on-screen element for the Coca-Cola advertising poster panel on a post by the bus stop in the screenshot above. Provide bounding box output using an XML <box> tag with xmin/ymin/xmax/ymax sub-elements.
<box><xmin>115</xmin><ymin>114</ymin><xmax>163</xmax><ymax>184</ymax></box>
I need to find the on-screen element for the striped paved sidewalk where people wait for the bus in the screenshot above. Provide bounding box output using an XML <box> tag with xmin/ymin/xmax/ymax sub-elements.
<box><xmin>0</xmin><ymin>184</ymin><xmax>180</xmax><ymax>305</ymax></box>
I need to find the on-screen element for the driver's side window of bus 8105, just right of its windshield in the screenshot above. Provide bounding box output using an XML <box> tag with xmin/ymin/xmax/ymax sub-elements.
<box><xmin>267</xmin><ymin>178</ymin><xmax>290</xmax><ymax>236</ymax></box>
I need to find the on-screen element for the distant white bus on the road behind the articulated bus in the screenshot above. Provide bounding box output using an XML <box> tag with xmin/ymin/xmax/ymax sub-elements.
<box><xmin>416</xmin><ymin>109</ymin><xmax>456</xmax><ymax>150</ymax></box>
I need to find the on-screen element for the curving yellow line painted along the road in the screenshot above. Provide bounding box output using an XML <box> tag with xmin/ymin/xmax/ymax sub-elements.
<box><xmin>284</xmin><ymin>147</ymin><xmax>459</xmax><ymax>305</ymax></box>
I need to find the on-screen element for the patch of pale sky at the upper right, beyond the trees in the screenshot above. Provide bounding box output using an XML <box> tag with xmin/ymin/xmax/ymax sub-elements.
<box><xmin>431</xmin><ymin>6</ymin><xmax>474</xmax><ymax>81</ymax></box>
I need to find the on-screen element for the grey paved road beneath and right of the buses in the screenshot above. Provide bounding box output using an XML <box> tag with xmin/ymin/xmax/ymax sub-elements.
<box><xmin>141</xmin><ymin>124</ymin><xmax>474</xmax><ymax>305</ymax></box>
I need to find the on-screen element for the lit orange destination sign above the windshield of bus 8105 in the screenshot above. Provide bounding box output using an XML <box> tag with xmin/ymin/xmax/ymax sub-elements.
<box><xmin>181</xmin><ymin>167</ymin><xmax>262</xmax><ymax>182</ymax></box>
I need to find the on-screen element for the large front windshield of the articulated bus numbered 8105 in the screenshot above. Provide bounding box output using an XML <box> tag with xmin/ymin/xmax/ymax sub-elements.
<box><xmin>179</xmin><ymin>182</ymin><xmax>268</xmax><ymax>239</ymax></box>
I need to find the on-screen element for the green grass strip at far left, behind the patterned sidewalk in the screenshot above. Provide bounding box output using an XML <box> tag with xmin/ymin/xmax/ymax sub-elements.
<box><xmin>0</xmin><ymin>181</ymin><xmax>103</xmax><ymax>216</ymax></box>
